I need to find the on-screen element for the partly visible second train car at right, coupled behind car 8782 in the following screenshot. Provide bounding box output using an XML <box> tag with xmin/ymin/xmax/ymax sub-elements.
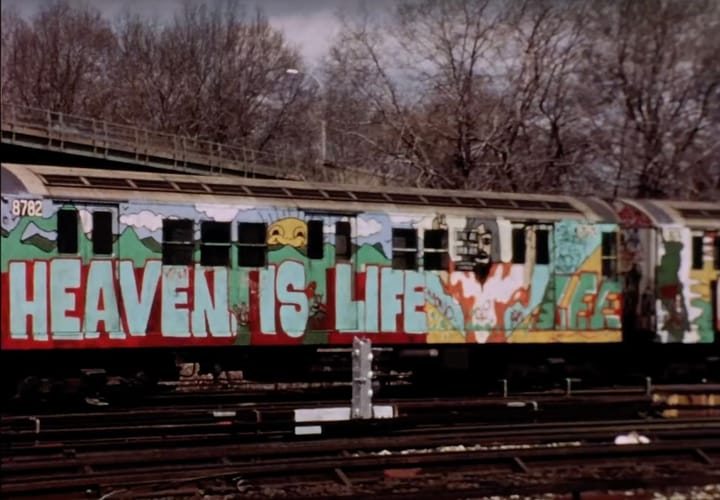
<box><xmin>615</xmin><ymin>200</ymin><xmax>720</xmax><ymax>344</ymax></box>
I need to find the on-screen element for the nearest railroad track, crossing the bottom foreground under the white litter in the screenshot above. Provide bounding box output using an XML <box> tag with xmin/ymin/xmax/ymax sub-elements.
<box><xmin>0</xmin><ymin>419</ymin><xmax>720</xmax><ymax>498</ymax></box>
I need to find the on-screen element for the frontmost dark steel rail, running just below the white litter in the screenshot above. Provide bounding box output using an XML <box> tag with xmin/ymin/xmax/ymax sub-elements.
<box><xmin>0</xmin><ymin>438</ymin><xmax>720</xmax><ymax>494</ymax></box>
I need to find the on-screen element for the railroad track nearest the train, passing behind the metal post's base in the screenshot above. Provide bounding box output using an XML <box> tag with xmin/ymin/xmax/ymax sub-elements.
<box><xmin>0</xmin><ymin>385</ymin><xmax>720</xmax><ymax>442</ymax></box>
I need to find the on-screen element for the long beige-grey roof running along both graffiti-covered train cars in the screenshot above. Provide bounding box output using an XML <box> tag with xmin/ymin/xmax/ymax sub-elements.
<box><xmin>2</xmin><ymin>163</ymin><xmax>720</xmax><ymax>225</ymax></box>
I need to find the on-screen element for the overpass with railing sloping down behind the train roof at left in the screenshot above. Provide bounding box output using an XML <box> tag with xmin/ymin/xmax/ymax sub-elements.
<box><xmin>1</xmin><ymin>104</ymin><xmax>400</xmax><ymax>184</ymax></box>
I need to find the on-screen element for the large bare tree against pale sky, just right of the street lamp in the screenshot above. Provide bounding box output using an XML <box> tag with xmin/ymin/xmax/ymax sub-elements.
<box><xmin>328</xmin><ymin>0</ymin><xmax>581</xmax><ymax>190</ymax></box>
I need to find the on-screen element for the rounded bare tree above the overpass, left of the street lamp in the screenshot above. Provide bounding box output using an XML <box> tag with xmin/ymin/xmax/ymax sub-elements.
<box><xmin>115</xmin><ymin>2</ymin><xmax>312</xmax><ymax>158</ymax></box>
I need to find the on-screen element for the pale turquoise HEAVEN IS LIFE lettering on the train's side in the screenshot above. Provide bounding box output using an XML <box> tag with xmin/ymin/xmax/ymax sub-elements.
<box><xmin>3</xmin><ymin>258</ymin><xmax>427</xmax><ymax>341</ymax></box>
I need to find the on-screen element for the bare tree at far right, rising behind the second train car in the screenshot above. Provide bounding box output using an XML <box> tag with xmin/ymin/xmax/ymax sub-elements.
<box><xmin>583</xmin><ymin>0</ymin><xmax>720</xmax><ymax>197</ymax></box>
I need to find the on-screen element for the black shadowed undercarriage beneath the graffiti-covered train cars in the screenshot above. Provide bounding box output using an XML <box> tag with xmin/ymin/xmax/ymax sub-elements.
<box><xmin>1</xmin><ymin>336</ymin><xmax>720</xmax><ymax>410</ymax></box>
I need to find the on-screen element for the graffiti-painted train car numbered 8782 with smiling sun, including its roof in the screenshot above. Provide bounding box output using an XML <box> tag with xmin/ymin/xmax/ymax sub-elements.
<box><xmin>2</xmin><ymin>166</ymin><xmax>622</xmax><ymax>349</ymax></box>
